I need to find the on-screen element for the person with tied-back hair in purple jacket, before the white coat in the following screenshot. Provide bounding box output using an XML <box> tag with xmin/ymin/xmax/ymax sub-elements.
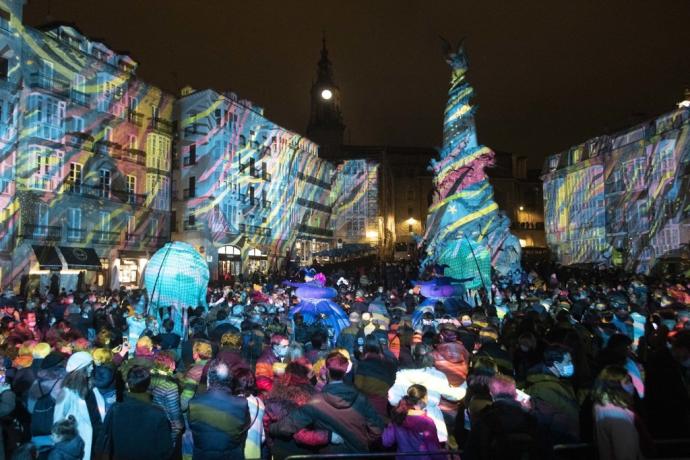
<box><xmin>382</xmin><ymin>385</ymin><xmax>442</xmax><ymax>460</ymax></box>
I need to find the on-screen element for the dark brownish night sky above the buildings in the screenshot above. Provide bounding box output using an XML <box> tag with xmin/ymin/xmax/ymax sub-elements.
<box><xmin>25</xmin><ymin>0</ymin><xmax>690</xmax><ymax>167</ymax></box>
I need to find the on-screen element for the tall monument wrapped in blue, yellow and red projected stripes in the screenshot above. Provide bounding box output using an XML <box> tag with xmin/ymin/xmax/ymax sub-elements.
<box><xmin>423</xmin><ymin>41</ymin><xmax>521</xmax><ymax>288</ymax></box>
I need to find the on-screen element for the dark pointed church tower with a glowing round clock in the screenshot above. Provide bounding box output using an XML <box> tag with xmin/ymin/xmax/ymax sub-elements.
<box><xmin>307</xmin><ymin>34</ymin><xmax>345</xmax><ymax>159</ymax></box>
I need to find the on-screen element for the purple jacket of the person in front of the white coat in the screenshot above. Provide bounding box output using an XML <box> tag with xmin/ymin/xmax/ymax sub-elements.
<box><xmin>383</xmin><ymin>414</ymin><xmax>445</xmax><ymax>460</ymax></box>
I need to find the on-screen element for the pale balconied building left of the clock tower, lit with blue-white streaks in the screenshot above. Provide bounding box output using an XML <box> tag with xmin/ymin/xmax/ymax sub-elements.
<box><xmin>175</xmin><ymin>89</ymin><xmax>333</xmax><ymax>277</ymax></box>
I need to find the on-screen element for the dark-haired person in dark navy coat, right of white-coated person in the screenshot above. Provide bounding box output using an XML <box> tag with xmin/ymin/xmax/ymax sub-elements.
<box><xmin>96</xmin><ymin>366</ymin><xmax>173</xmax><ymax>460</ymax></box>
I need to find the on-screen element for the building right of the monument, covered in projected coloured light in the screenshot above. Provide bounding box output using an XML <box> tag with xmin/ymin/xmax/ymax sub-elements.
<box><xmin>543</xmin><ymin>108</ymin><xmax>690</xmax><ymax>273</ymax></box>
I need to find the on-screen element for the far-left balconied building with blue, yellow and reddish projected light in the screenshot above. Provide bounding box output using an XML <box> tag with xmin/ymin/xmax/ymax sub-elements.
<box><xmin>0</xmin><ymin>9</ymin><xmax>173</xmax><ymax>287</ymax></box>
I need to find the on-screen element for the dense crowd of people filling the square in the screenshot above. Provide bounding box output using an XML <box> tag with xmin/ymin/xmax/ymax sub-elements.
<box><xmin>0</xmin><ymin>264</ymin><xmax>690</xmax><ymax>460</ymax></box>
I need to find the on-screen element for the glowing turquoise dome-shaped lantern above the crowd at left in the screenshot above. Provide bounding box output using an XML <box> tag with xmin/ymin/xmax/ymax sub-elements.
<box><xmin>144</xmin><ymin>241</ymin><xmax>210</xmax><ymax>308</ymax></box>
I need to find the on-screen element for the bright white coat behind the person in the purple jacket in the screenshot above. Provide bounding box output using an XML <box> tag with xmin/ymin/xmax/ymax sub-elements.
<box><xmin>388</xmin><ymin>367</ymin><xmax>466</xmax><ymax>442</ymax></box>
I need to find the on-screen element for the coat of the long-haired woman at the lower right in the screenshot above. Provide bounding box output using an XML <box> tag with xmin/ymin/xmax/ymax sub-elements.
<box><xmin>594</xmin><ymin>404</ymin><xmax>644</xmax><ymax>460</ymax></box>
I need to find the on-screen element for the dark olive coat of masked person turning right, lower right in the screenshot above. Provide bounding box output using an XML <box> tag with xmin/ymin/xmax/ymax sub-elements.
<box><xmin>525</xmin><ymin>367</ymin><xmax>580</xmax><ymax>444</ymax></box>
